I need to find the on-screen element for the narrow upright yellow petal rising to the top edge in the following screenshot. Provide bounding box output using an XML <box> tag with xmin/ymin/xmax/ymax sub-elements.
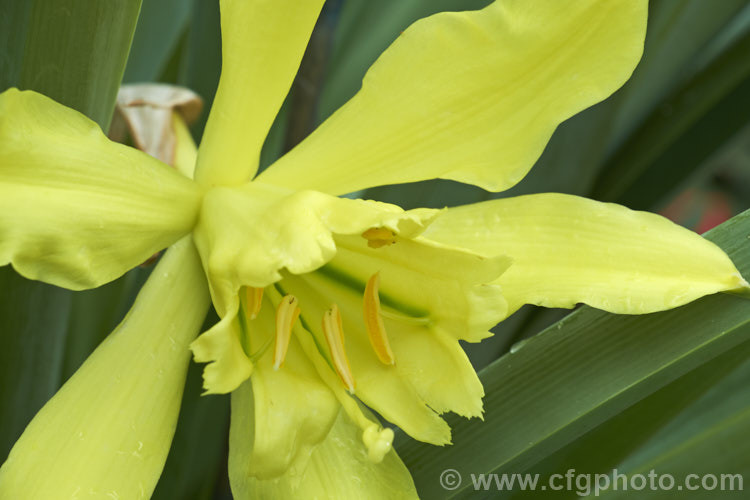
<box><xmin>196</xmin><ymin>0</ymin><xmax>323</xmax><ymax>186</ymax></box>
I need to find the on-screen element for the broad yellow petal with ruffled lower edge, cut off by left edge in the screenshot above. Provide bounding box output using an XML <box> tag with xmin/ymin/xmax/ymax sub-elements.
<box><xmin>0</xmin><ymin>89</ymin><xmax>201</xmax><ymax>290</ymax></box>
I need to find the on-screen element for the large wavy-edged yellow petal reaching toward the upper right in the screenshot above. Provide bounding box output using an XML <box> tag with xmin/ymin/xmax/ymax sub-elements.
<box><xmin>259</xmin><ymin>0</ymin><xmax>647</xmax><ymax>194</ymax></box>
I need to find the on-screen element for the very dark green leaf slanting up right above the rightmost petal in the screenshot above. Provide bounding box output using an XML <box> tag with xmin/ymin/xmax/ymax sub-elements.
<box><xmin>593</xmin><ymin>20</ymin><xmax>750</xmax><ymax>209</ymax></box>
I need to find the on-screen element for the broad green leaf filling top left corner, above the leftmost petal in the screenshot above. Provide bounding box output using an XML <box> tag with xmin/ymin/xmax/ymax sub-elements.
<box><xmin>0</xmin><ymin>0</ymin><xmax>141</xmax><ymax>131</ymax></box>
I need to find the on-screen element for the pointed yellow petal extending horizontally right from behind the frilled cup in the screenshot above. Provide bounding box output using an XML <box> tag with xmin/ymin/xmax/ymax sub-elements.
<box><xmin>425</xmin><ymin>194</ymin><xmax>747</xmax><ymax>314</ymax></box>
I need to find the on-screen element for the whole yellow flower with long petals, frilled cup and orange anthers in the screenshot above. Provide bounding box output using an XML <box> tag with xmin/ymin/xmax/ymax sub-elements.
<box><xmin>0</xmin><ymin>0</ymin><xmax>747</xmax><ymax>499</ymax></box>
